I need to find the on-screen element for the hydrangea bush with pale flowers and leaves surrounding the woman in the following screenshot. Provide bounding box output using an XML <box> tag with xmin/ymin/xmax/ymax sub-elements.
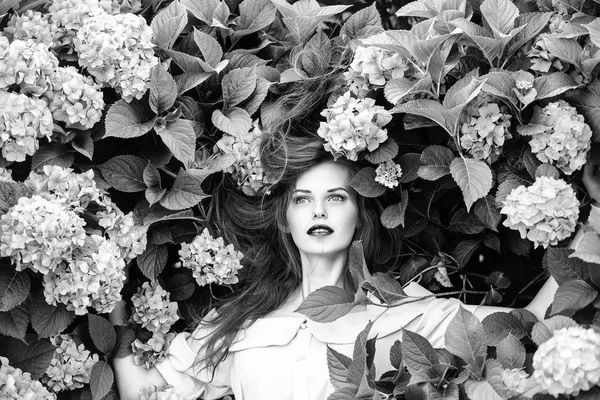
<box><xmin>0</xmin><ymin>0</ymin><xmax>600</xmax><ymax>400</ymax></box>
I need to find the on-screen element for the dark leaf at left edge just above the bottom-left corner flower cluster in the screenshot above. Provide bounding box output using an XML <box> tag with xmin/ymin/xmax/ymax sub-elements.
<box><xmin>0</xmin><ymin>336</ymin><xmax>56</xmax><ymax>379</ymax></box>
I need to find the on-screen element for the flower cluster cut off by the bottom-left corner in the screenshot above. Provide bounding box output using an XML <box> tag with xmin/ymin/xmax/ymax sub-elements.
<box><xmin>0</xmin><ymin>357</ymin><xmax>56</xmax><ymax>400</ymax></box>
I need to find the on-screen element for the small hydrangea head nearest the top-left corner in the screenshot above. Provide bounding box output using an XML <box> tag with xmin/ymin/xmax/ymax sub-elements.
<box><xmin>4</xmin><ymin>10</ymin><xmax>58</xmax><ymax>47</ymax></box>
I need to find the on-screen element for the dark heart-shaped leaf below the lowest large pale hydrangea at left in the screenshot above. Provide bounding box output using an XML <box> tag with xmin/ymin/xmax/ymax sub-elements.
<box><xmin>29</xmin><ymin>292</ymin><xmax>75</xmax><ymax>338</ymax></box>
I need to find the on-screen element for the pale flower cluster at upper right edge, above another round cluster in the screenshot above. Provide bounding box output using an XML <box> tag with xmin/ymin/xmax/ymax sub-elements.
<box><xmin>529</xmin><ymin>100</ymin><xmax>592</xmax><ymax>175</ymax></box>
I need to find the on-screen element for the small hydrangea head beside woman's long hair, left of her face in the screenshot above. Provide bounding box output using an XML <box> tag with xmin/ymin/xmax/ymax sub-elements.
<box><xmin>179</xmin><ymin>228</ymin><xmax>244</xmax><ymax>286</ymax></box>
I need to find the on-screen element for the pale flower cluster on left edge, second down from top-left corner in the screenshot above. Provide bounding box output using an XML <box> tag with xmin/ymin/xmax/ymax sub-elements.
<box><xmin>0</xmin><ymin>36</ymin><xmax>58</xmax><ymax>96</ymax></box>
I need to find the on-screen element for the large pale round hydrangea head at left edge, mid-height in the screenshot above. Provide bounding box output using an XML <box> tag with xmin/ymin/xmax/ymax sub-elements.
<box><xmin>0</xmin><ymin>195</ymin><xmax>85</xmax><ymax>274</ymax></box>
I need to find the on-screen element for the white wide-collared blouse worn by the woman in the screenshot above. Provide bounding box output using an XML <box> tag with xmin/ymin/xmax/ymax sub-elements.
<box><xmin>156</xmin><ymin>283</ymin><xmax>476</xmax><ymax>400</ymax></box>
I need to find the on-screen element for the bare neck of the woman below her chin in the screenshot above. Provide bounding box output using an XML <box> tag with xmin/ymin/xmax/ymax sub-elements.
<box><xmin>301</xmin><ymin>253</ymin><xmax>348</xmax><ymax>298</ymax></box>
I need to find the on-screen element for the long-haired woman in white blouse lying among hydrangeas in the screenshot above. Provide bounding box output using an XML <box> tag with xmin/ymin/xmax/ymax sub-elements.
<box><xmin>113</xmin><ymin>126</ymin><xmax>556</xmax><ymax>400</ymax></box>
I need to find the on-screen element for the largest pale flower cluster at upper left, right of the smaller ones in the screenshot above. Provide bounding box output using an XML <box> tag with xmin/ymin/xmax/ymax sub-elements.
<box><xmin>74</xmin><ymin>13</ymin><xmax>159</xmax><ymax>101</ymax></box>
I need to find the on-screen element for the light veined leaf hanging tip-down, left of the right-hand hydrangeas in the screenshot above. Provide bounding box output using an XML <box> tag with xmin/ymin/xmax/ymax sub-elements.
<box><xmin>450</xmin><ymin>157</ymin><xmax>492</xmax><ymax>211</ymax></box>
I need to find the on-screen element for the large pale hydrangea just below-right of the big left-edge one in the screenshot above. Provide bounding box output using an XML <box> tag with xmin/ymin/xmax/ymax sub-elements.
<box><xmin>44</xmin><ymin>235</ymin><xmax>126</xmax><ymax>315</ymax></box>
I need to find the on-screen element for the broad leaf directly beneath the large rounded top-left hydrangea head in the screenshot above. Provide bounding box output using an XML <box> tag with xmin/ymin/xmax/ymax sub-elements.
<box><xmin>104</xmin><ymin>99</ymin><xmax>154</xmax><ymax>139</ymax></box>
